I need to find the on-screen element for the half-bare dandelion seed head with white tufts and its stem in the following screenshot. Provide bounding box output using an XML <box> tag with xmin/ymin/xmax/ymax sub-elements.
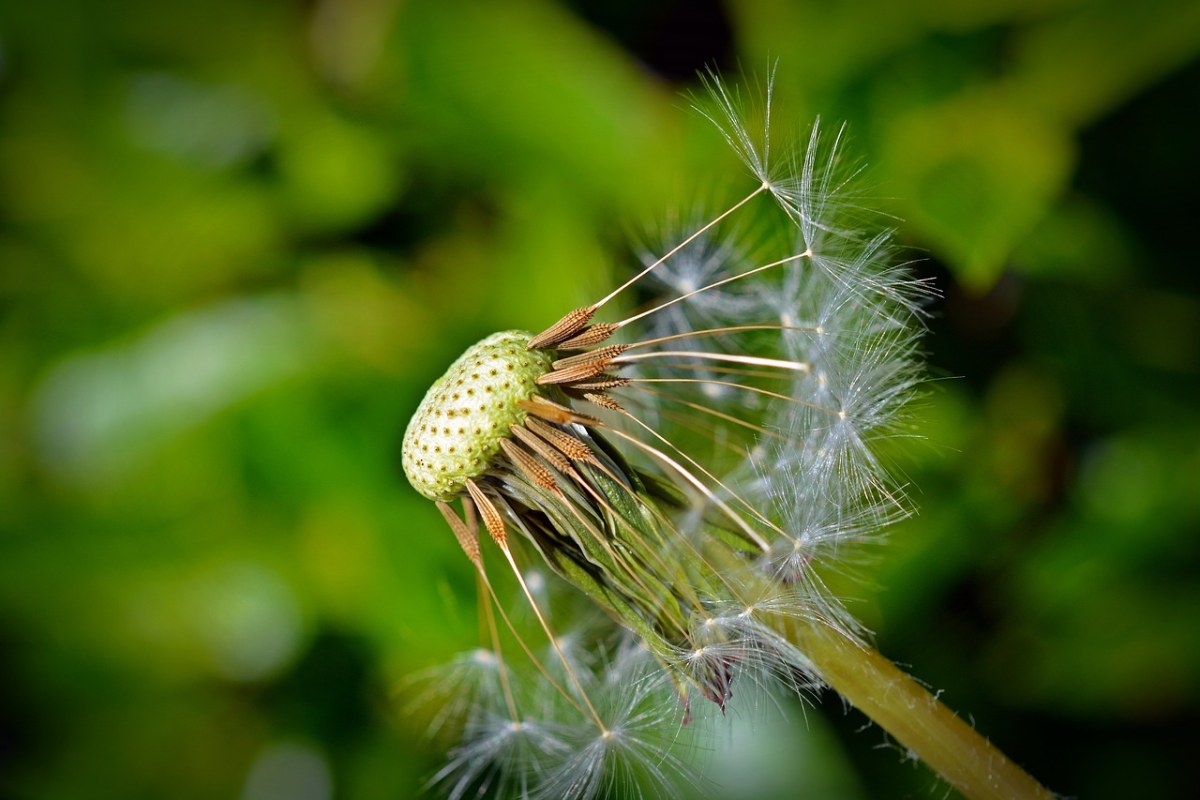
<box><xmin>403</xmin><ymin>76</ymin><xmax>1048</xmax><ymax>799</ymax></box>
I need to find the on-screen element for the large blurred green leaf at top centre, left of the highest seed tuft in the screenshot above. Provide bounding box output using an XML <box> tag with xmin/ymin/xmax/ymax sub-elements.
<box><xmin>400</xmin><ymin>0</ymin><xmax>671</xmax><ymax>203</ymax></box>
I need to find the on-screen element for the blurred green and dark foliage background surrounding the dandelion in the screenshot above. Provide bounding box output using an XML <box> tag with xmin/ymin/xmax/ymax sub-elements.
<box><xmin>0</xmin><ymin>0</ymin><xmax>1200</xmax><ymax>800</ymax></box>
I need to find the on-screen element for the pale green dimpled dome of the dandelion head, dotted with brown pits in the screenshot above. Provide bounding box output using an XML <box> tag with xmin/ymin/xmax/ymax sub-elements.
<box><xmin>403</xmin><ymin>331</ymin><xmax>552</xmax><ymax>500</ymax></box>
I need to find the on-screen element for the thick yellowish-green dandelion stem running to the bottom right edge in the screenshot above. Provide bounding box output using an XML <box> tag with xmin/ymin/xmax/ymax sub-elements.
<box><xmin>772</xmin><ymin>616</ymin><xmax>1055</xmax><ymax>800</ymax></box>
